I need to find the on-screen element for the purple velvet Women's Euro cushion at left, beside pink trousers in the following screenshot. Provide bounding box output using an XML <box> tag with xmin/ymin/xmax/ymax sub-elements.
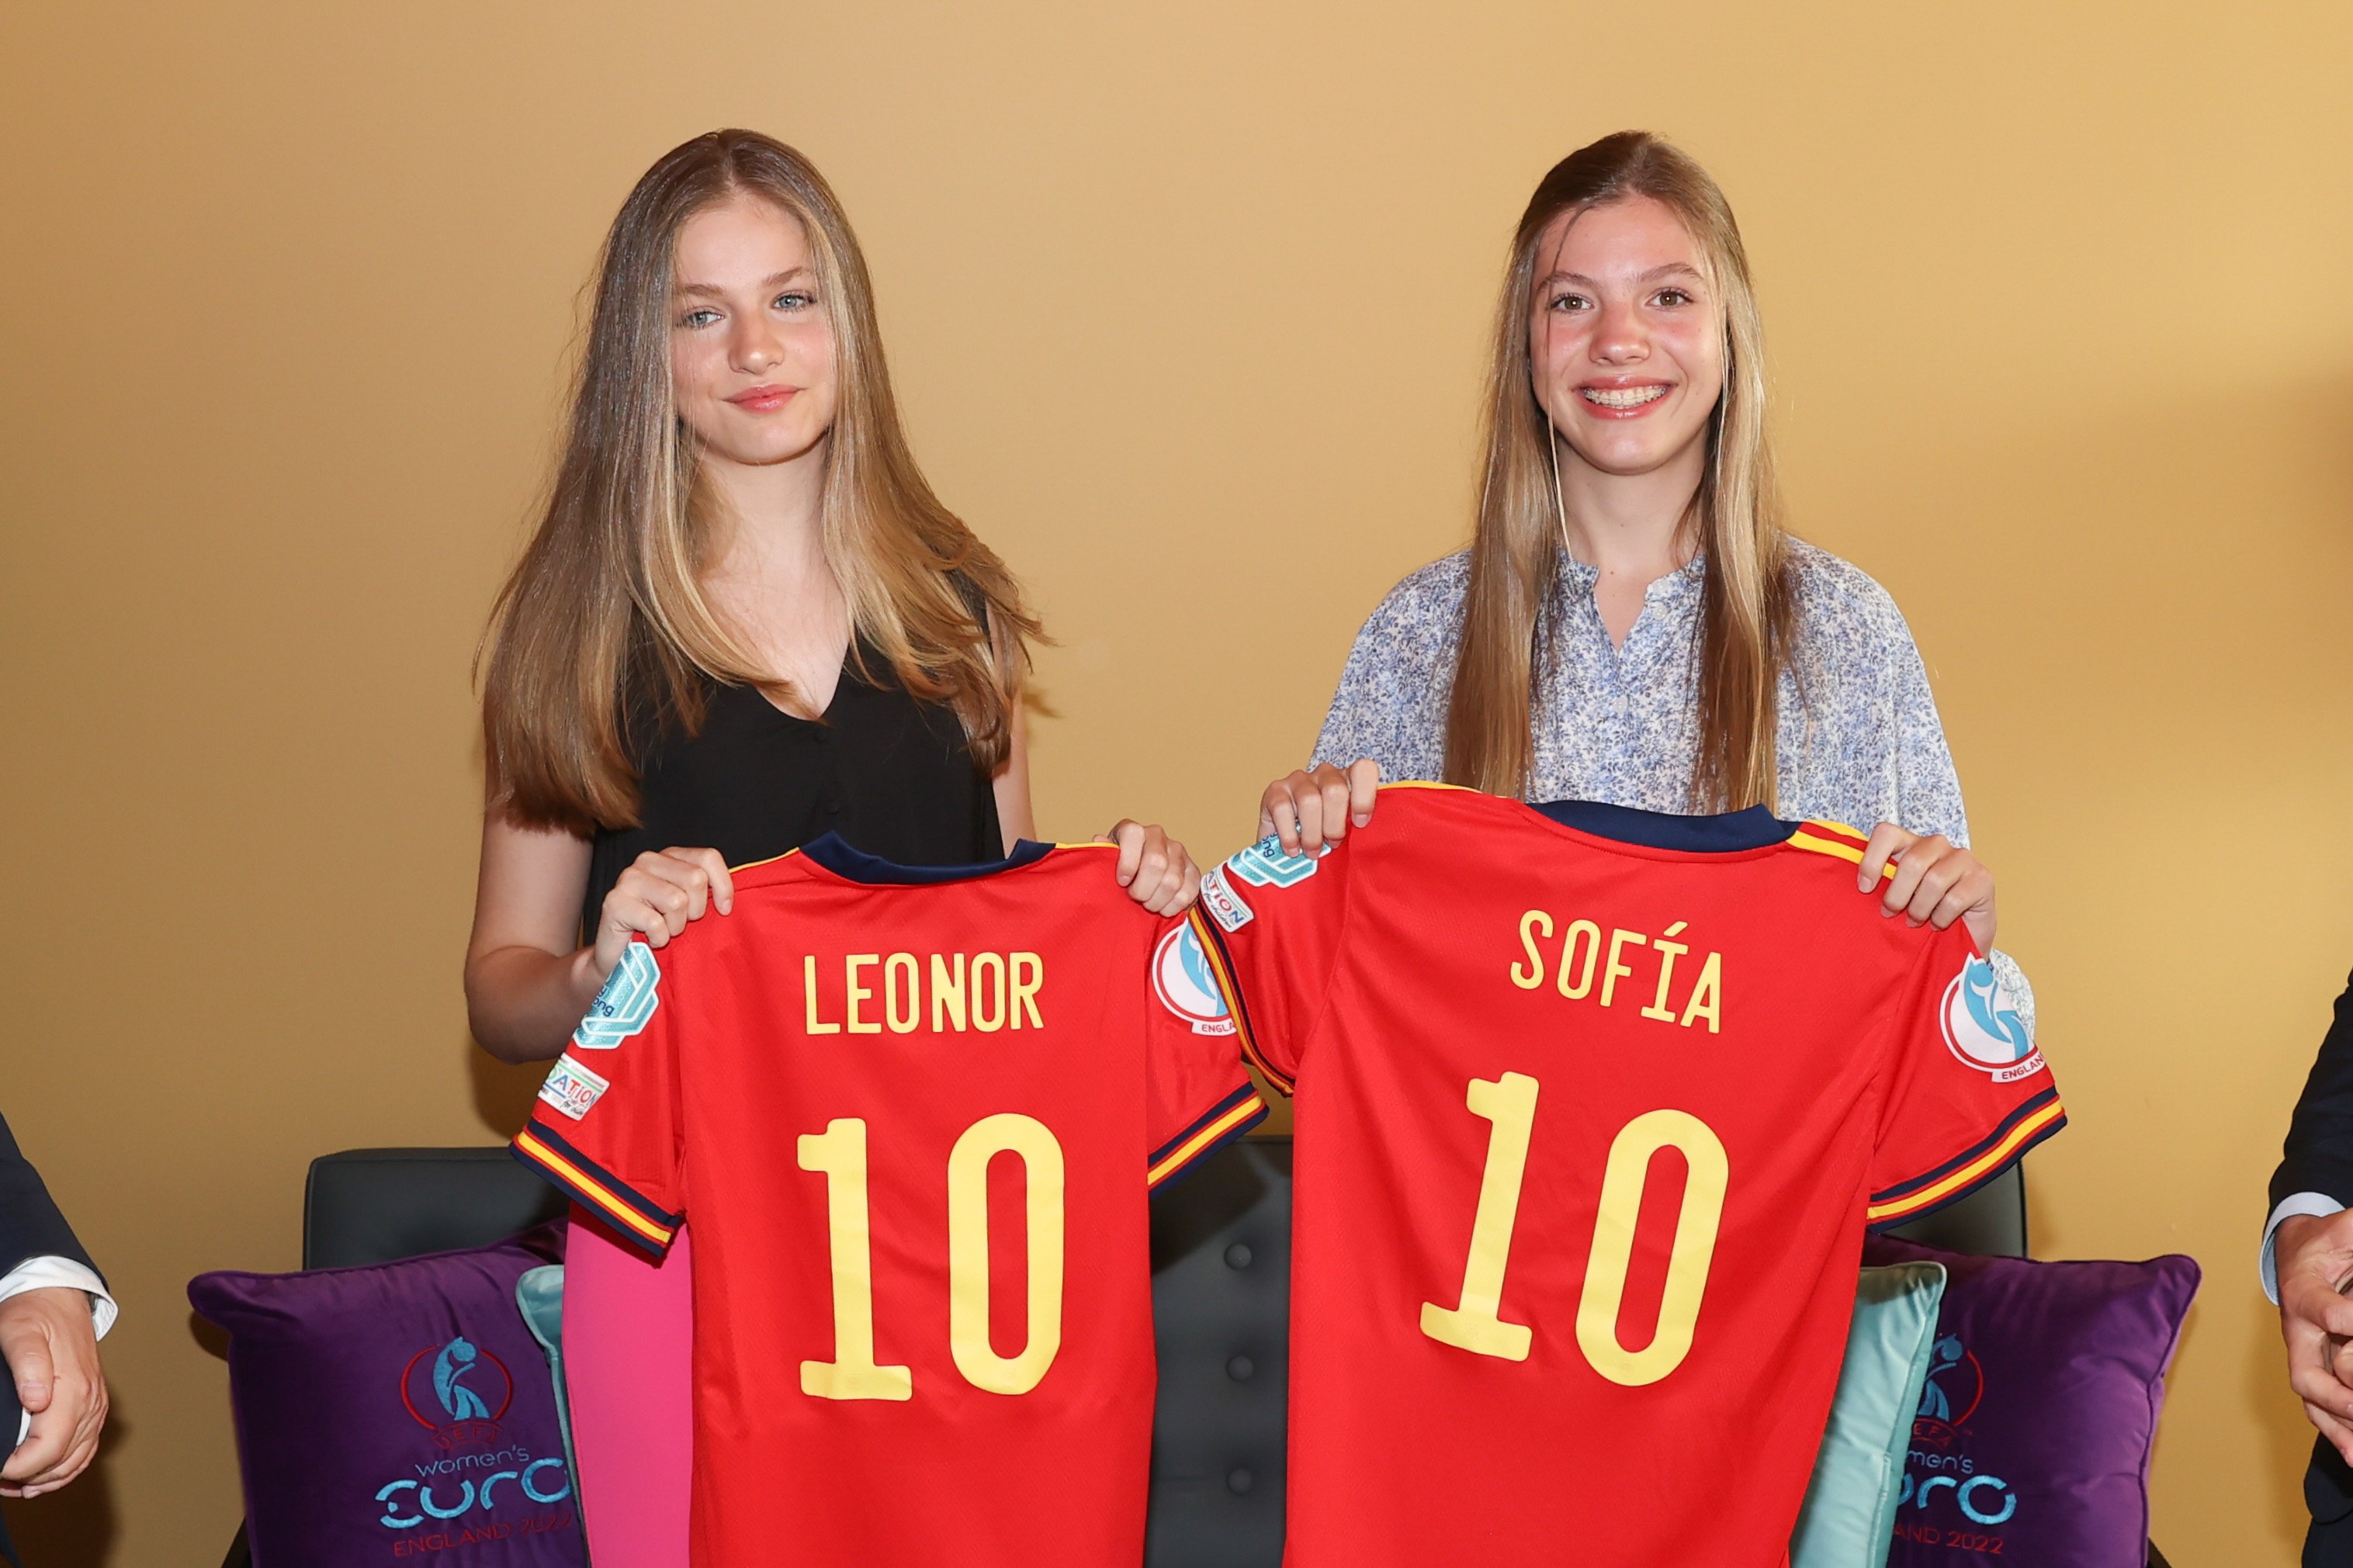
<box><xmin>189</xmin><ymin>1225</ymin><xmax>588</xmax><ymax>1568</ymax></box>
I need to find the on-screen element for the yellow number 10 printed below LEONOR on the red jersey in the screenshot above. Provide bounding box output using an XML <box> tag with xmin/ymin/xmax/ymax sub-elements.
<box><xmin>800</xmin><ymin>1114</ymin><xmax>1063</xmax><ymax>1399</ymax></box>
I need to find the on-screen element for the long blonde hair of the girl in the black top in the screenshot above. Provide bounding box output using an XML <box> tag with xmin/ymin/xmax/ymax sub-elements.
<box><xmin>483</xmin><ymin>130</ymin><xmax>1038</xmax><ymax>832</ymax></box>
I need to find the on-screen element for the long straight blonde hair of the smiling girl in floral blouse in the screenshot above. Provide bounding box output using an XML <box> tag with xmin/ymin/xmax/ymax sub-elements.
<box><xmin>1445</xmin><ymin>132</ymin><xmax>1795</xmax><ymax>811</ymax></box>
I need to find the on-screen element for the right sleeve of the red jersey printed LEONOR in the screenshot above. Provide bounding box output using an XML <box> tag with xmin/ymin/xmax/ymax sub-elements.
<box><xmin>1144</xmin><ymin>917</ymin><xmax>1266</xmax><ymax>1192</ymax></box>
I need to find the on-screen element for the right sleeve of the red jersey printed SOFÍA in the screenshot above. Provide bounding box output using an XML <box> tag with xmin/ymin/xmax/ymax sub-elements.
<box><xmin>1870</xmin><ymin>924</ymin><xmax>2066</xmax><ymax>1230</ymax></box>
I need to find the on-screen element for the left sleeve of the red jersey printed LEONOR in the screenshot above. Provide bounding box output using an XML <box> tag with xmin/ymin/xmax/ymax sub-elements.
<box><xmin>513</xmin><ymin>943</ymin><xmax>687</xmax><ymax>1258</ymax></box>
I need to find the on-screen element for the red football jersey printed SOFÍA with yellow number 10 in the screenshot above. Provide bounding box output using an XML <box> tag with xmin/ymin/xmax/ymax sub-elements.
<box><xmin>1193</xmin><ymin>785</ymin><xmax>2061</xmax><ymax>1568</ymax></box>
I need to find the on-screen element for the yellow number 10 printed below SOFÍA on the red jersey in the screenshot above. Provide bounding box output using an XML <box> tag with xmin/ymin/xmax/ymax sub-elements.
<box><xmin>1421</xmin><ymin>1072</ymin><xmax>1730</xmax><ymax>1387</ymax></box>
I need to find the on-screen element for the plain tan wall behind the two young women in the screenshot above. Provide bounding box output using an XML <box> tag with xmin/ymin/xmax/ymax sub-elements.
<box><xmin>0</xmin><ymin>0</ymin><xmax>2353</xmax><ymax>1568</ymax></box>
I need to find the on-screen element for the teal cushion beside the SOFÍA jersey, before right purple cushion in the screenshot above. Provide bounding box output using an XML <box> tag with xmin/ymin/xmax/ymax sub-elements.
<box><xmin>1788</xmin><ymin>1262</ymin><xmax>1943</xmax><ymax>1568</ymax></box>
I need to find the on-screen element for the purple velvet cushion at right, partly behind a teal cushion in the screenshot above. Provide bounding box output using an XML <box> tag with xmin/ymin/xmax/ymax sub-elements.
<box><xmin>1863</xmin><ymin>1237</ymin><xmax>2198</xmax><ymax>1568</ymax></box>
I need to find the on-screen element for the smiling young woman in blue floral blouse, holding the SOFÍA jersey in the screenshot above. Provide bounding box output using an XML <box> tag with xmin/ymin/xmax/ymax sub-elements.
<box><xmin>1259</xmin><ymin>132</ymin><xmax>2033</xmax><ymax>1023</ymax></box>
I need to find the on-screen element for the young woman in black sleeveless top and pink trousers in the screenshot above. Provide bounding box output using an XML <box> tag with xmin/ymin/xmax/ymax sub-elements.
<box><xmin>466</xmin><ymin>132</ymin><xmax>1197</xmax><ymax>1568</ymax></box>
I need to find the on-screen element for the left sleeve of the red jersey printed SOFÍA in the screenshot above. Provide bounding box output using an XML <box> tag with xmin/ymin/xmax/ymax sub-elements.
<box><xmin>1193</xmin><ymin>837</ymin><xmax>1355</xmax><ymax>1093</ymax></box>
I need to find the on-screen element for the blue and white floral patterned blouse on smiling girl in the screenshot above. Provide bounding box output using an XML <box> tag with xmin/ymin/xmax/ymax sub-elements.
<box><xmin>1315</xmin><ymin>543</ymin><xmax>2036</xmax><ymax>1030</ymax></box>
